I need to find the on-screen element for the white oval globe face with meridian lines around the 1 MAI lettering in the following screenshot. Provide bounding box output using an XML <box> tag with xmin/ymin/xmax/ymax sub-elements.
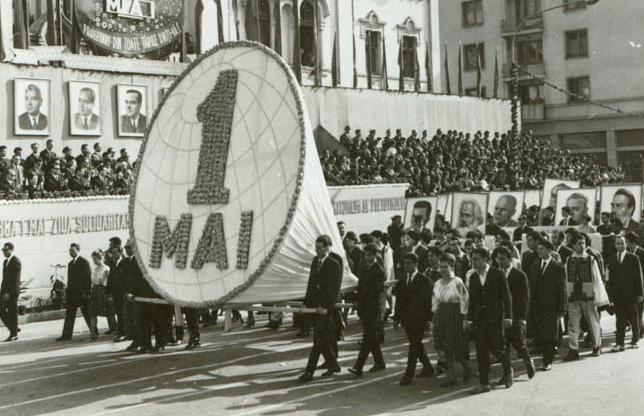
<box><xmin>130</xmin><ymin>44</ymin><xmax>306</xmax><ymax>304</ymax></box>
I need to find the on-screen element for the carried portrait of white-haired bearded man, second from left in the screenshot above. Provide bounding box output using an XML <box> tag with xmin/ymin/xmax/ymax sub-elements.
<box><xmin>452</xmin><ymin>192</ymin><xmax>489</xmax><ymax>237</ymax></box>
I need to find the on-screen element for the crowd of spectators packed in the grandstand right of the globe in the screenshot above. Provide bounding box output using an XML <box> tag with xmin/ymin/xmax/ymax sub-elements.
<box><xmin>321</xmin><ymin>126</ymin><xmax>624</xmax><ymax>196</ymax></box>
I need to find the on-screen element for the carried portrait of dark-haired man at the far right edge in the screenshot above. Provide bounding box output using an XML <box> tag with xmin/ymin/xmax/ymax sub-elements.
<box><xmin>599</xmin><ymin>184</ymin><xmax>642</xmax><ymax>233</ymax></box>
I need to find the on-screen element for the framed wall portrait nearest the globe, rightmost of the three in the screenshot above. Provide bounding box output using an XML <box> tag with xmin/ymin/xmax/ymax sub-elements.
<box><xmin>116</xmin><ymin>84</ymin><xmax>149</xmax><ymax>137</ymax></box>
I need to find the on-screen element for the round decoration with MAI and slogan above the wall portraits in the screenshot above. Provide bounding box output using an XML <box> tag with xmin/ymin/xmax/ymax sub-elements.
<box><xmin>75</xmin><ymin>0</ymin><xmax>183</xmax><ymax>59</ymax></box>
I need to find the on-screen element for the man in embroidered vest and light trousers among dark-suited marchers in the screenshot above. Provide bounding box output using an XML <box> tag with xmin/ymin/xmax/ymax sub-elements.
<box><xmin>564</xmin><ymin>233</ymin><xmax>603</xmax><ymax>361</ymax></box>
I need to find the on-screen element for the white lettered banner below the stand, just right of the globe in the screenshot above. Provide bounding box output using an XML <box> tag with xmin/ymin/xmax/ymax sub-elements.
<box><xmin>328</xmin><ymin>183</ymin><xmax>409</xmax><ymax>235</ymax></box>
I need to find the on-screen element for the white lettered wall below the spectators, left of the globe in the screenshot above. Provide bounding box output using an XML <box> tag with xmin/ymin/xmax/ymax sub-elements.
<box><xmin>0</xmin><ymin>196</ymin><xmax>128</xmax><ymax>300</ymax></box>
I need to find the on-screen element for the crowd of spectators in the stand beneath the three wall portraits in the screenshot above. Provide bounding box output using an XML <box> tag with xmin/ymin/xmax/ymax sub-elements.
<box><xmin>0</xmin><ymin>140</ymin><xmax>133</xmax><ymax>200</ymax></box>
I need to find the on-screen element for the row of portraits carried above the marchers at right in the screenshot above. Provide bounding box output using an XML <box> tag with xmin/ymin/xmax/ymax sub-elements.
<box><xmin>404</xmin><ymin>182</ymin><xmax>642</xmax><ymax>235</ymax></box>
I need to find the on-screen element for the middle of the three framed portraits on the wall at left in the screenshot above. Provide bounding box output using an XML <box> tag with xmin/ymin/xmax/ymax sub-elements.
<box><xmin>69</xmin><ymin>81</ymin><xmax>103</xmax><ymax>136</ymax></box>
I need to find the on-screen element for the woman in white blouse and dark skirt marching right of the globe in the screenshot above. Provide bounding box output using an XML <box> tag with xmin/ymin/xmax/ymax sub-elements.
<box><xmin>432</xmin><ymin>254</ymin><xmax>471</xmax><ymax>387</ymax></box>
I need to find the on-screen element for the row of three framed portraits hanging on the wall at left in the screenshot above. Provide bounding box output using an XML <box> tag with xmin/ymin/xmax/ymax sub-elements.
<box><xmin>14</xmin><ymin>78</ymin><xmax>148</xmax><ymax>137</ymax></box>
